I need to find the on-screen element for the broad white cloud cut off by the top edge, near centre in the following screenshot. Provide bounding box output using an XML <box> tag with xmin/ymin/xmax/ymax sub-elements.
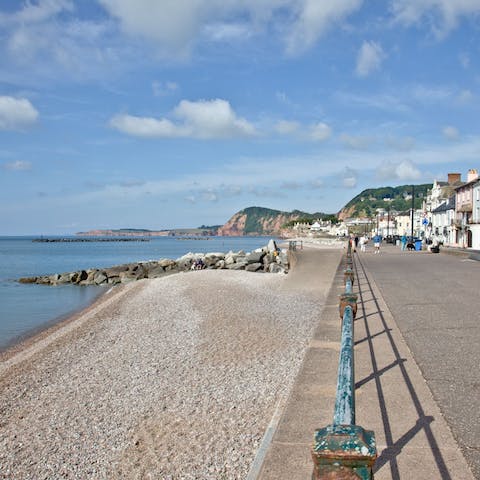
<box><xmin>99</xmin><ymin>0</ymin><xmax>362</xmax><ymax>56</ymax></box>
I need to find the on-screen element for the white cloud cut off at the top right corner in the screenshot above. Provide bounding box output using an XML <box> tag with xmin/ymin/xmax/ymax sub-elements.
<box><xmin>391</xmin><ymin>0</ymin><xmax>480</xmax><ymax>38</ymax></box>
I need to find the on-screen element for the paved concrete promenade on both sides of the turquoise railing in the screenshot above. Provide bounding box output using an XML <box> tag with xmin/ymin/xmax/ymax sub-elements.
<box><xmin>258</xmin><ymin>245</ymin><xmax>480</xmax><ymax>480</ymax></box>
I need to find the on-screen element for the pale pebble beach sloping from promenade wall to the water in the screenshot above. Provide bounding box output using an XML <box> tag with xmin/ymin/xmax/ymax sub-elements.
<box><xmin>0</xmin><ymin>248</ymin><xmax>341</xmax><ymax>480</ymax></box>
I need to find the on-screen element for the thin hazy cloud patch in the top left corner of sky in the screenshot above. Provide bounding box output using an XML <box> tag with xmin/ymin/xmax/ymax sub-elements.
<box><xmin>0</xmin><ymin>0</ymin><xmax>136</xmax><ymax>85</ymax></box>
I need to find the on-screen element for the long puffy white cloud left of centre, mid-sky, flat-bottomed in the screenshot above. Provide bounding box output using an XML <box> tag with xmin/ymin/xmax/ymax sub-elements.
<box><xmin>110</xmin><ymin>99</ymin><xmax>256</xmax><ymax>139</ymax></box>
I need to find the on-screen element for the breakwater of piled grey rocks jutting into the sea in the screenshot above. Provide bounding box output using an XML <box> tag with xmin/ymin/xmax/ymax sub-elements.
<box><xmin>19</xmin><ymin>240</ymin><xmax>289</xmax><ymax>285</ymax></box>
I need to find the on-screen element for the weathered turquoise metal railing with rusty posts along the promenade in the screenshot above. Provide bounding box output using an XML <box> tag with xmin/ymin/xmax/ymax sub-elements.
<box><xmin>312</xmin><ymin>242</ymin><xmax>377</xmax><ymax>480</ymax></box>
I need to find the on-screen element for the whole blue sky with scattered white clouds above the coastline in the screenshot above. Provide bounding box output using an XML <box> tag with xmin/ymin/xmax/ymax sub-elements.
<box><xmin>0</xmin><ymin>0</ymin><xmax>480</xmax><ymax>235</ymax></box>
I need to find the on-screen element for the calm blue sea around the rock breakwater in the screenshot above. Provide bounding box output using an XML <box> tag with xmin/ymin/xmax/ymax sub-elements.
<box><xmin>0</xmin><ymin>237</ymin><xmax>276</xmax><ymax>350</ymax></box>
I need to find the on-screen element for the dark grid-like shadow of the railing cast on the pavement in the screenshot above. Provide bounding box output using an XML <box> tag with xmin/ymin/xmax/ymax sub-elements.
<box><xmin>354</xmin><ymin>255</ymin><xmax>452</xmax><ymax>480</ymax></box>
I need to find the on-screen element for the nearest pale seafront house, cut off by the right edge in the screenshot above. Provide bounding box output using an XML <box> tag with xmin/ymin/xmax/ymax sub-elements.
<box><xmin>454</xmin><ymin>168</ymin><xmax>478</xmax><ymax>248</ymax></box>
